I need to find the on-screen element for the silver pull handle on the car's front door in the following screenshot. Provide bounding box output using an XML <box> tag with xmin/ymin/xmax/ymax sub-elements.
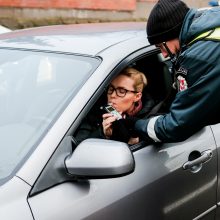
<box><xmin>183</xmin><ymin>150</ymin><xmax>212</xmax><ymax>170</ymax></box>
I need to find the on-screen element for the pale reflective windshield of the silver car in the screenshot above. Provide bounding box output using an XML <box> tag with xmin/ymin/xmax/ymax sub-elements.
<box><xmin>0</xmin><ymin>50</ymin><xmax>100</xmax><ymax>182</ymax></box>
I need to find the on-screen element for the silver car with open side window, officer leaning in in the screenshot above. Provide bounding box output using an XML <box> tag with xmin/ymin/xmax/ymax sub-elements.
<box><xmin>0</xmin><ymin>23</ymin><xmax>220</xmax><ymax>220</ymax></box>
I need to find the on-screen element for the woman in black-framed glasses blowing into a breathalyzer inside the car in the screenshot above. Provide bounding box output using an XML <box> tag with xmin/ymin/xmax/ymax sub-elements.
<box><xmin>102</xmin><ymin>67</ymin><xmax>153</xmax><ymax>144</ymax></box>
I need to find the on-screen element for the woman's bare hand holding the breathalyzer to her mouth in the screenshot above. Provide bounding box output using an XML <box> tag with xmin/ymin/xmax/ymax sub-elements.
<box><xmin>102</xmin><ymin>113</ymin><xmax>117</xmax><ymax>139</ymax></box>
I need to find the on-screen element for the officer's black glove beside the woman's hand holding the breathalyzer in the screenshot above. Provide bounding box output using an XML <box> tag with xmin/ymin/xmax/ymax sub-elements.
<box><xmin>111</xmin><ymin>117</ymin><xmax>138</xmax><ymax>143</ymax></box>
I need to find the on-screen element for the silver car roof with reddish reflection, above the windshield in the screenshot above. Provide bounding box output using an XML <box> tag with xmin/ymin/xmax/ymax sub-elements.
<box><xmin>0</xmin><ymin>22</ymin><xmax>147</xmax><ymax>56</ymax></box>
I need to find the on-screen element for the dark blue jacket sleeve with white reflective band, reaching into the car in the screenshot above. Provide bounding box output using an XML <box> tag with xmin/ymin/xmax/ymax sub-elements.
<box><xmin>135</xmin><ymin>77</ymin><xmax>213</xmax><ymax>142</ymax></box>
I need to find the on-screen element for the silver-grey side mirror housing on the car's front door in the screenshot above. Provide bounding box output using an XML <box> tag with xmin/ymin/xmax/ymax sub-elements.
<box><xmin>65</xmin><ymin>139</ymin><xmax>135</xmax><ymax>179</ymax></box>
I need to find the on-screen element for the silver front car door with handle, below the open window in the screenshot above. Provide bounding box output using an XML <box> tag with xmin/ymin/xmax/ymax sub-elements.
<box><xmin>28</xmin><ymin>127</ymin><xmax>217</xmax><ymax>220</ymax></box>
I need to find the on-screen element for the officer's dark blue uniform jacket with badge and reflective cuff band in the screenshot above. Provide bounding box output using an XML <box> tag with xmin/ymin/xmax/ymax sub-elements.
<box><xmin>135</xmin><ymin>8</ymin><xmax>220</xmax><ymax>142</ymax></box>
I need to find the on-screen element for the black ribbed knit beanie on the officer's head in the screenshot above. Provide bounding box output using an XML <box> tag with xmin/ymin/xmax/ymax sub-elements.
<box><xmin>147</xmin><ymin>0</ymin><xmax>189</xmax><ymax>44</ymax></box>
